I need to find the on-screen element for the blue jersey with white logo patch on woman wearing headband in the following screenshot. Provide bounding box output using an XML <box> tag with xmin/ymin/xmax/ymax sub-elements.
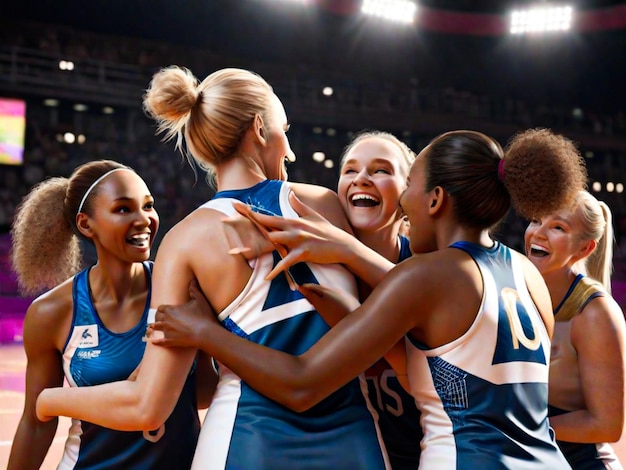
<box><xmin>58</xmin><ymin>262</ymin><xmax>200</xmax><ymax>470</ymax></box>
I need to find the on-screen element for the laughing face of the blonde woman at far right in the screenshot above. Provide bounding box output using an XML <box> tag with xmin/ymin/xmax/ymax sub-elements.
<box><xmin>524</xmin><ymin>207</ymin><xmax>588</xmax><ymax>274</ymax></box>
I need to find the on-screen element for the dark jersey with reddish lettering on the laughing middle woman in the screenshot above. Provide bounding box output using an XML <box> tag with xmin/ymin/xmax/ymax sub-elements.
<box><xmin>365</xmin><ymin>236</ymin><xmax>423</xmax><ymax>470</ymax></box>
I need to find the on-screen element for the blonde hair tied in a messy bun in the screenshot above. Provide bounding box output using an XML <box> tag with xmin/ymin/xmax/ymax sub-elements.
<box><xmin>143</xmin><ymin>66</ymin><xmax>273</xmax><ymax>185</ymax></box>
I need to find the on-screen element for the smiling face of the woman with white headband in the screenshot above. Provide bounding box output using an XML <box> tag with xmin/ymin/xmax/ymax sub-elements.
<box><xmin>84</xmin><ymin>171</ymin><xmax>159</xmax><ymax>262</ymax></box>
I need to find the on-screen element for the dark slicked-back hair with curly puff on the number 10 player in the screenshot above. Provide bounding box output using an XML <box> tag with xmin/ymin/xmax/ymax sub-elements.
<box><xmin>425</xmin><ymin>129</ymin><xmax>587</xmax><ymax>229</ymax></box>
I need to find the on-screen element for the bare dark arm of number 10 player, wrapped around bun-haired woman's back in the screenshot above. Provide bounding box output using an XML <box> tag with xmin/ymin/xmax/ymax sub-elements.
<box><xmin>151</xmin><ymin>263</ymin><xmax>429</xmax><ymax>411</ymax></box>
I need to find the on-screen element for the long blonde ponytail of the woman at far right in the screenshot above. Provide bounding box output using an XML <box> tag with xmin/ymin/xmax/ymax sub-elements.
<box><xmin>574</xmin><ymin>191</ymin><xmax>613</xmax><ymax>293</ymax></box>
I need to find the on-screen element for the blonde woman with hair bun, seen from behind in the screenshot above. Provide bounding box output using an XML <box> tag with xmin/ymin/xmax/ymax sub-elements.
<box><xmin>37</xmin><ymin>67</ymin><xmax>388</xmax><ymax>470</ymax></box>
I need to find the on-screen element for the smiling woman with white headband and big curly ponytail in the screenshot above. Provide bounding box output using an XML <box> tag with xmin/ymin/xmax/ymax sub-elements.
<box><xmin>8</xmin><ymin>160</ymin><xmax>199</xmax><ymax>470</ymax></box>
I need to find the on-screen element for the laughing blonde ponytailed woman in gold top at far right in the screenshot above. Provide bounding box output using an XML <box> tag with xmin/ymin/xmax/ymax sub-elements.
<box><xmin>525</xmin><ymin>184</ymin><xmax>626</xmax><ymax>469</ymax></box>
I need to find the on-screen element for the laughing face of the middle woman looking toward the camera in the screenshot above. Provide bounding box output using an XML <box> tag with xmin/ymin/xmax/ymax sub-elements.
<box><xmin>337</xmin><ymin>137</ymin><xmax>408</xmax><ymax>237</ymax></box>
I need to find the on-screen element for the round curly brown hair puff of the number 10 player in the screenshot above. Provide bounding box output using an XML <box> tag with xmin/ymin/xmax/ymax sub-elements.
<box><xmin>504</xmin><ymin>128</ymin><xmax>587</xmax><ymax>219</ymax></box>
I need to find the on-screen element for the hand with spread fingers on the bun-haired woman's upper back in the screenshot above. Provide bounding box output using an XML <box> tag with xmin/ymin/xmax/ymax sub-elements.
<box><xmin>234</xmin><ymin>193</ymin><xmax>354</xmax><ymax>280</ymax></box>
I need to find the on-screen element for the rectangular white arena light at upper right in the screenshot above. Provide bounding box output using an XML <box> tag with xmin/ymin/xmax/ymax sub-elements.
<box><xmin>510</xmin><ymin>6</ymin><xmax>573</xmax><ymax>34</ymax></box>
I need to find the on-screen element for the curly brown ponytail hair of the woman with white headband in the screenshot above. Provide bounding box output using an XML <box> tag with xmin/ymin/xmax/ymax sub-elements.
<box><xmin>10</xmin><ymin>160</ymin><xmax>130</xmax><ymax>295</ymax></box>
